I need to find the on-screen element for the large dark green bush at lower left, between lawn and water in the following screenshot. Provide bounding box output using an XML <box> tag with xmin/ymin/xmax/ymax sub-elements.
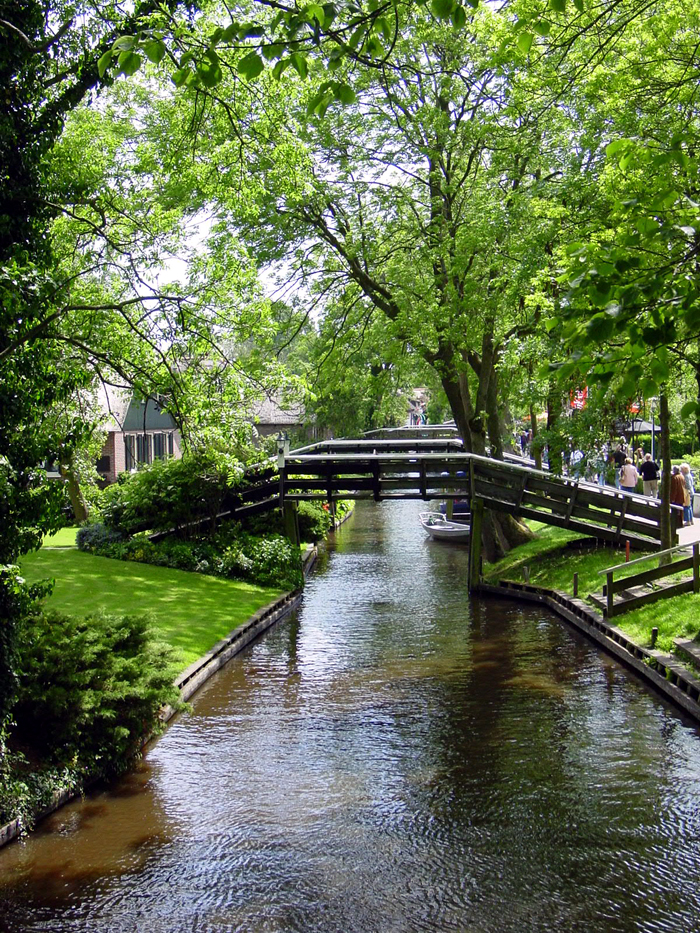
<box><xmin>15</xmin><ymin>613</ymin><xmax>178</xmax><ymax>776</ymax></box>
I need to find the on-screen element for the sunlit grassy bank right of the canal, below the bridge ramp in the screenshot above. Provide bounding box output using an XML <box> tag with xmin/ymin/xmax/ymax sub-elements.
<box><xmin>484</xmin><ymin>522</ymin><xmax>700</xmax><ymax>653</ymax></box>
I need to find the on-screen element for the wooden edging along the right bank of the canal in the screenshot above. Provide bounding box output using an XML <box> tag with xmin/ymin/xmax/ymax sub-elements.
<box><xmin>474</xmin><ymin>580</ymin><xmax>700</xmax><ymax>722</ymax></box>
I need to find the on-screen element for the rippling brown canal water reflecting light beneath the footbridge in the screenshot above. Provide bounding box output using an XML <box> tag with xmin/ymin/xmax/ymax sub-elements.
<box><xmin>0</xmin><ymin>502</ymin><xmax>700</xmax><ymax>933</ymax></box>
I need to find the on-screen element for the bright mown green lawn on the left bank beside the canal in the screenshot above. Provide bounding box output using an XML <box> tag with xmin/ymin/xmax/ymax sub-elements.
<box><xmin>22</xmin><ymin>548</ymin><xmax>283</xmax><ymax>668</ymax></box>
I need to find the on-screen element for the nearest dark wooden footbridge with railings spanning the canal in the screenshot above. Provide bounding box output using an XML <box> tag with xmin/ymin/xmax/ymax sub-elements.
<box><xmin>226</xmin><ymin>436</ymin><xmax>672</xmax><ymax>550</ymax></box>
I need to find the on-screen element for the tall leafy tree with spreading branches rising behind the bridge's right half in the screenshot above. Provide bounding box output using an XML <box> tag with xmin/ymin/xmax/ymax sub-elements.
<box><xmin>189</xmin><ymin>9</ymin><xmax>572</xmax><ymax>548</ymax></box>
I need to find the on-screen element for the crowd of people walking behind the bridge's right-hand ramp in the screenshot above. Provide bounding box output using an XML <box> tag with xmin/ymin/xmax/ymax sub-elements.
<box><xmin>516</xmin><ymin>429</ymin><xmax>695</xmax><ymax>525</ymax></box>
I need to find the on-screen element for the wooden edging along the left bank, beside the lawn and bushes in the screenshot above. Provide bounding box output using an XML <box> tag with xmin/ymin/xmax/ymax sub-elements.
<box><xmin>0</xmin><ymin>546</ymin><xmax>318</xmax><ymax>848</ymax></box>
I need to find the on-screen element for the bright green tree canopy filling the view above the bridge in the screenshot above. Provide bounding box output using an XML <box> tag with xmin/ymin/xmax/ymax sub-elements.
<box><xmin>0</xmin><ymin>0</ymin><xmax>700</xmax><ymax>712</ymax></box>
